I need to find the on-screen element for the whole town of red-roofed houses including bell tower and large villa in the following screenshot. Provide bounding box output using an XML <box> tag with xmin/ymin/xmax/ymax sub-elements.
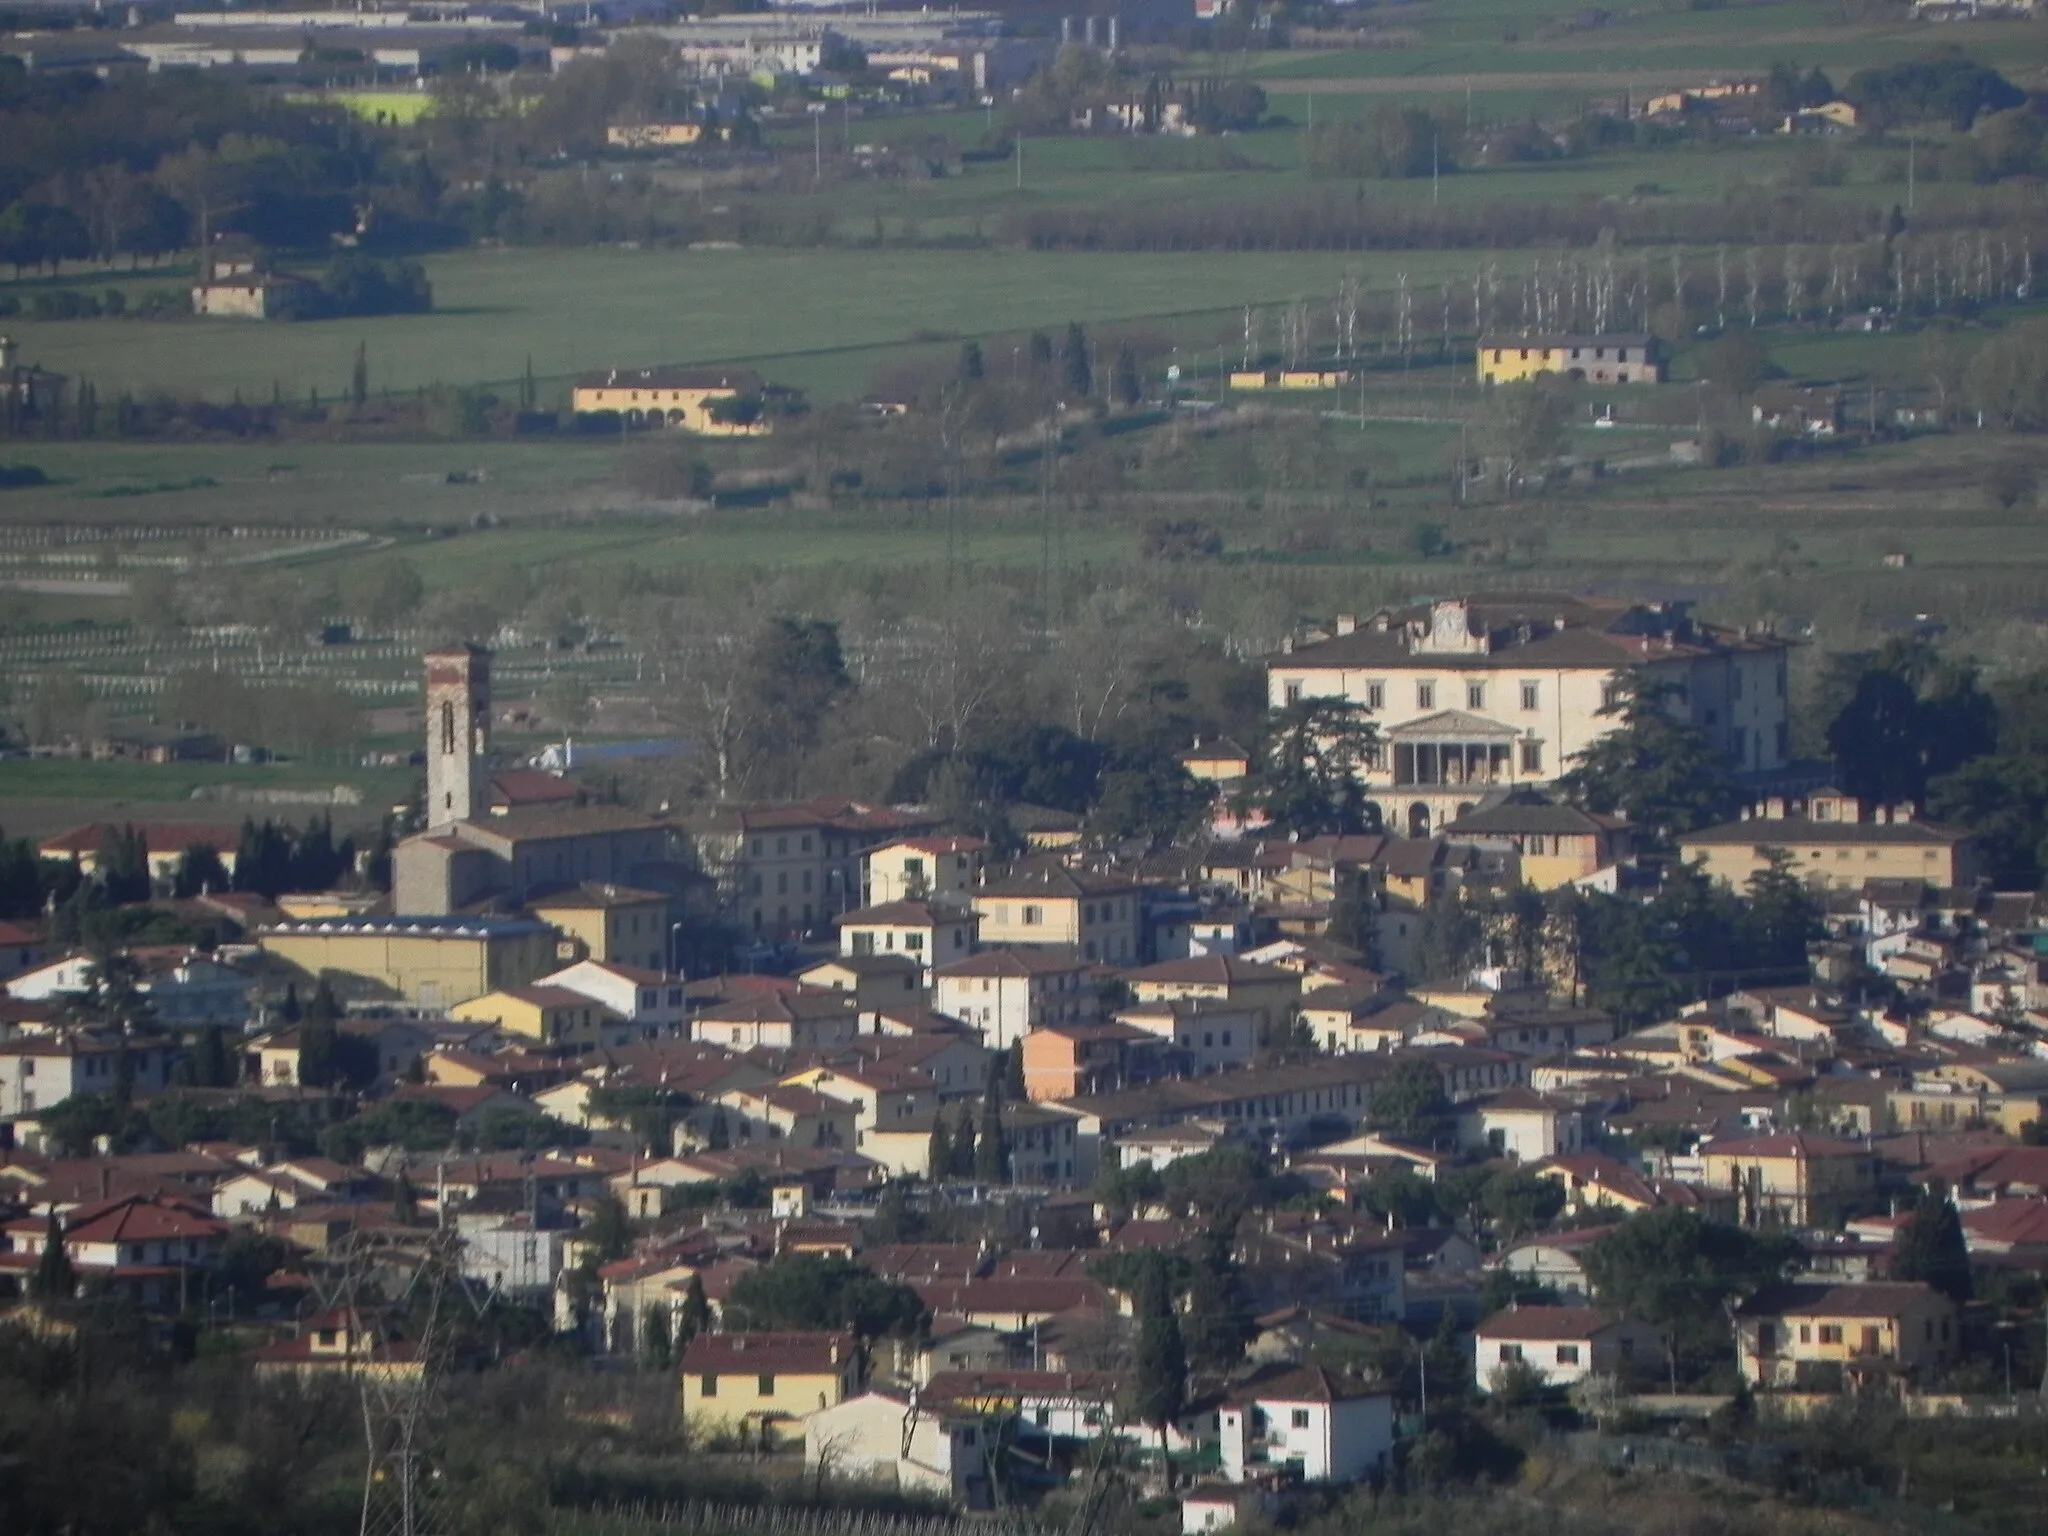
<box><xmin>0</xmin><ymin>592</ymin><xmax>2048</xmax><ymax>1532</ymax></box>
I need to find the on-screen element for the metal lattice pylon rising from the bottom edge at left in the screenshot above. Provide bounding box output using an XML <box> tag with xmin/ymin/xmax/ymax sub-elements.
<box><xmin>350</xmin><ymin>1231</ymin><xmax>461</xmax><ymax>1536</ymax></box>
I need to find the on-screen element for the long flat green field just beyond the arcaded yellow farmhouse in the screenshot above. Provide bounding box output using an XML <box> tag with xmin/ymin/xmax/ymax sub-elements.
<box><xmin>10</xmin><ymin>250</ymin><xmax>1507</xmax><ymax>403</ymax></box>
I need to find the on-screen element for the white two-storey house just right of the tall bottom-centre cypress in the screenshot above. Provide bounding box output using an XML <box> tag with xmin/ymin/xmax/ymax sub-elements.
<box><xmin>1217</xmin><ymin>1364</ymin><xmax>1395</xmax><ymax>1483</ymax></box>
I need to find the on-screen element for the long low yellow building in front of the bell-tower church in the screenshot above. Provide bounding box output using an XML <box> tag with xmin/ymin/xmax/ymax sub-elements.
<box><xmin>256</xmin><ymin>918</ymin><xmax>557</xmax><ymax>1008</ymax></box>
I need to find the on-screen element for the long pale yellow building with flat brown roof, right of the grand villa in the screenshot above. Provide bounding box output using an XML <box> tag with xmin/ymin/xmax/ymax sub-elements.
<box><xmin>1677</xmin><ymin>793</ymin><xmax>1976</xmax><ymax>891</ymax></box>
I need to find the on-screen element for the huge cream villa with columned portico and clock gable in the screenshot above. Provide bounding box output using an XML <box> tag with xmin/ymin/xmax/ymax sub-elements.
<box><xmin>1266</xmin><ymin>592</ymin><xmax>1792</xmax><ymax>838</ymax></box>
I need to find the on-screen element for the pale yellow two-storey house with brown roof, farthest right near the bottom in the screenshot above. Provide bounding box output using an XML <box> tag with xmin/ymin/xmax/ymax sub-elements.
<box><xmin>1735</xmin><ymin>1280</ymin><xmax>1960</xmax><ymax>1386</ymax></box>
